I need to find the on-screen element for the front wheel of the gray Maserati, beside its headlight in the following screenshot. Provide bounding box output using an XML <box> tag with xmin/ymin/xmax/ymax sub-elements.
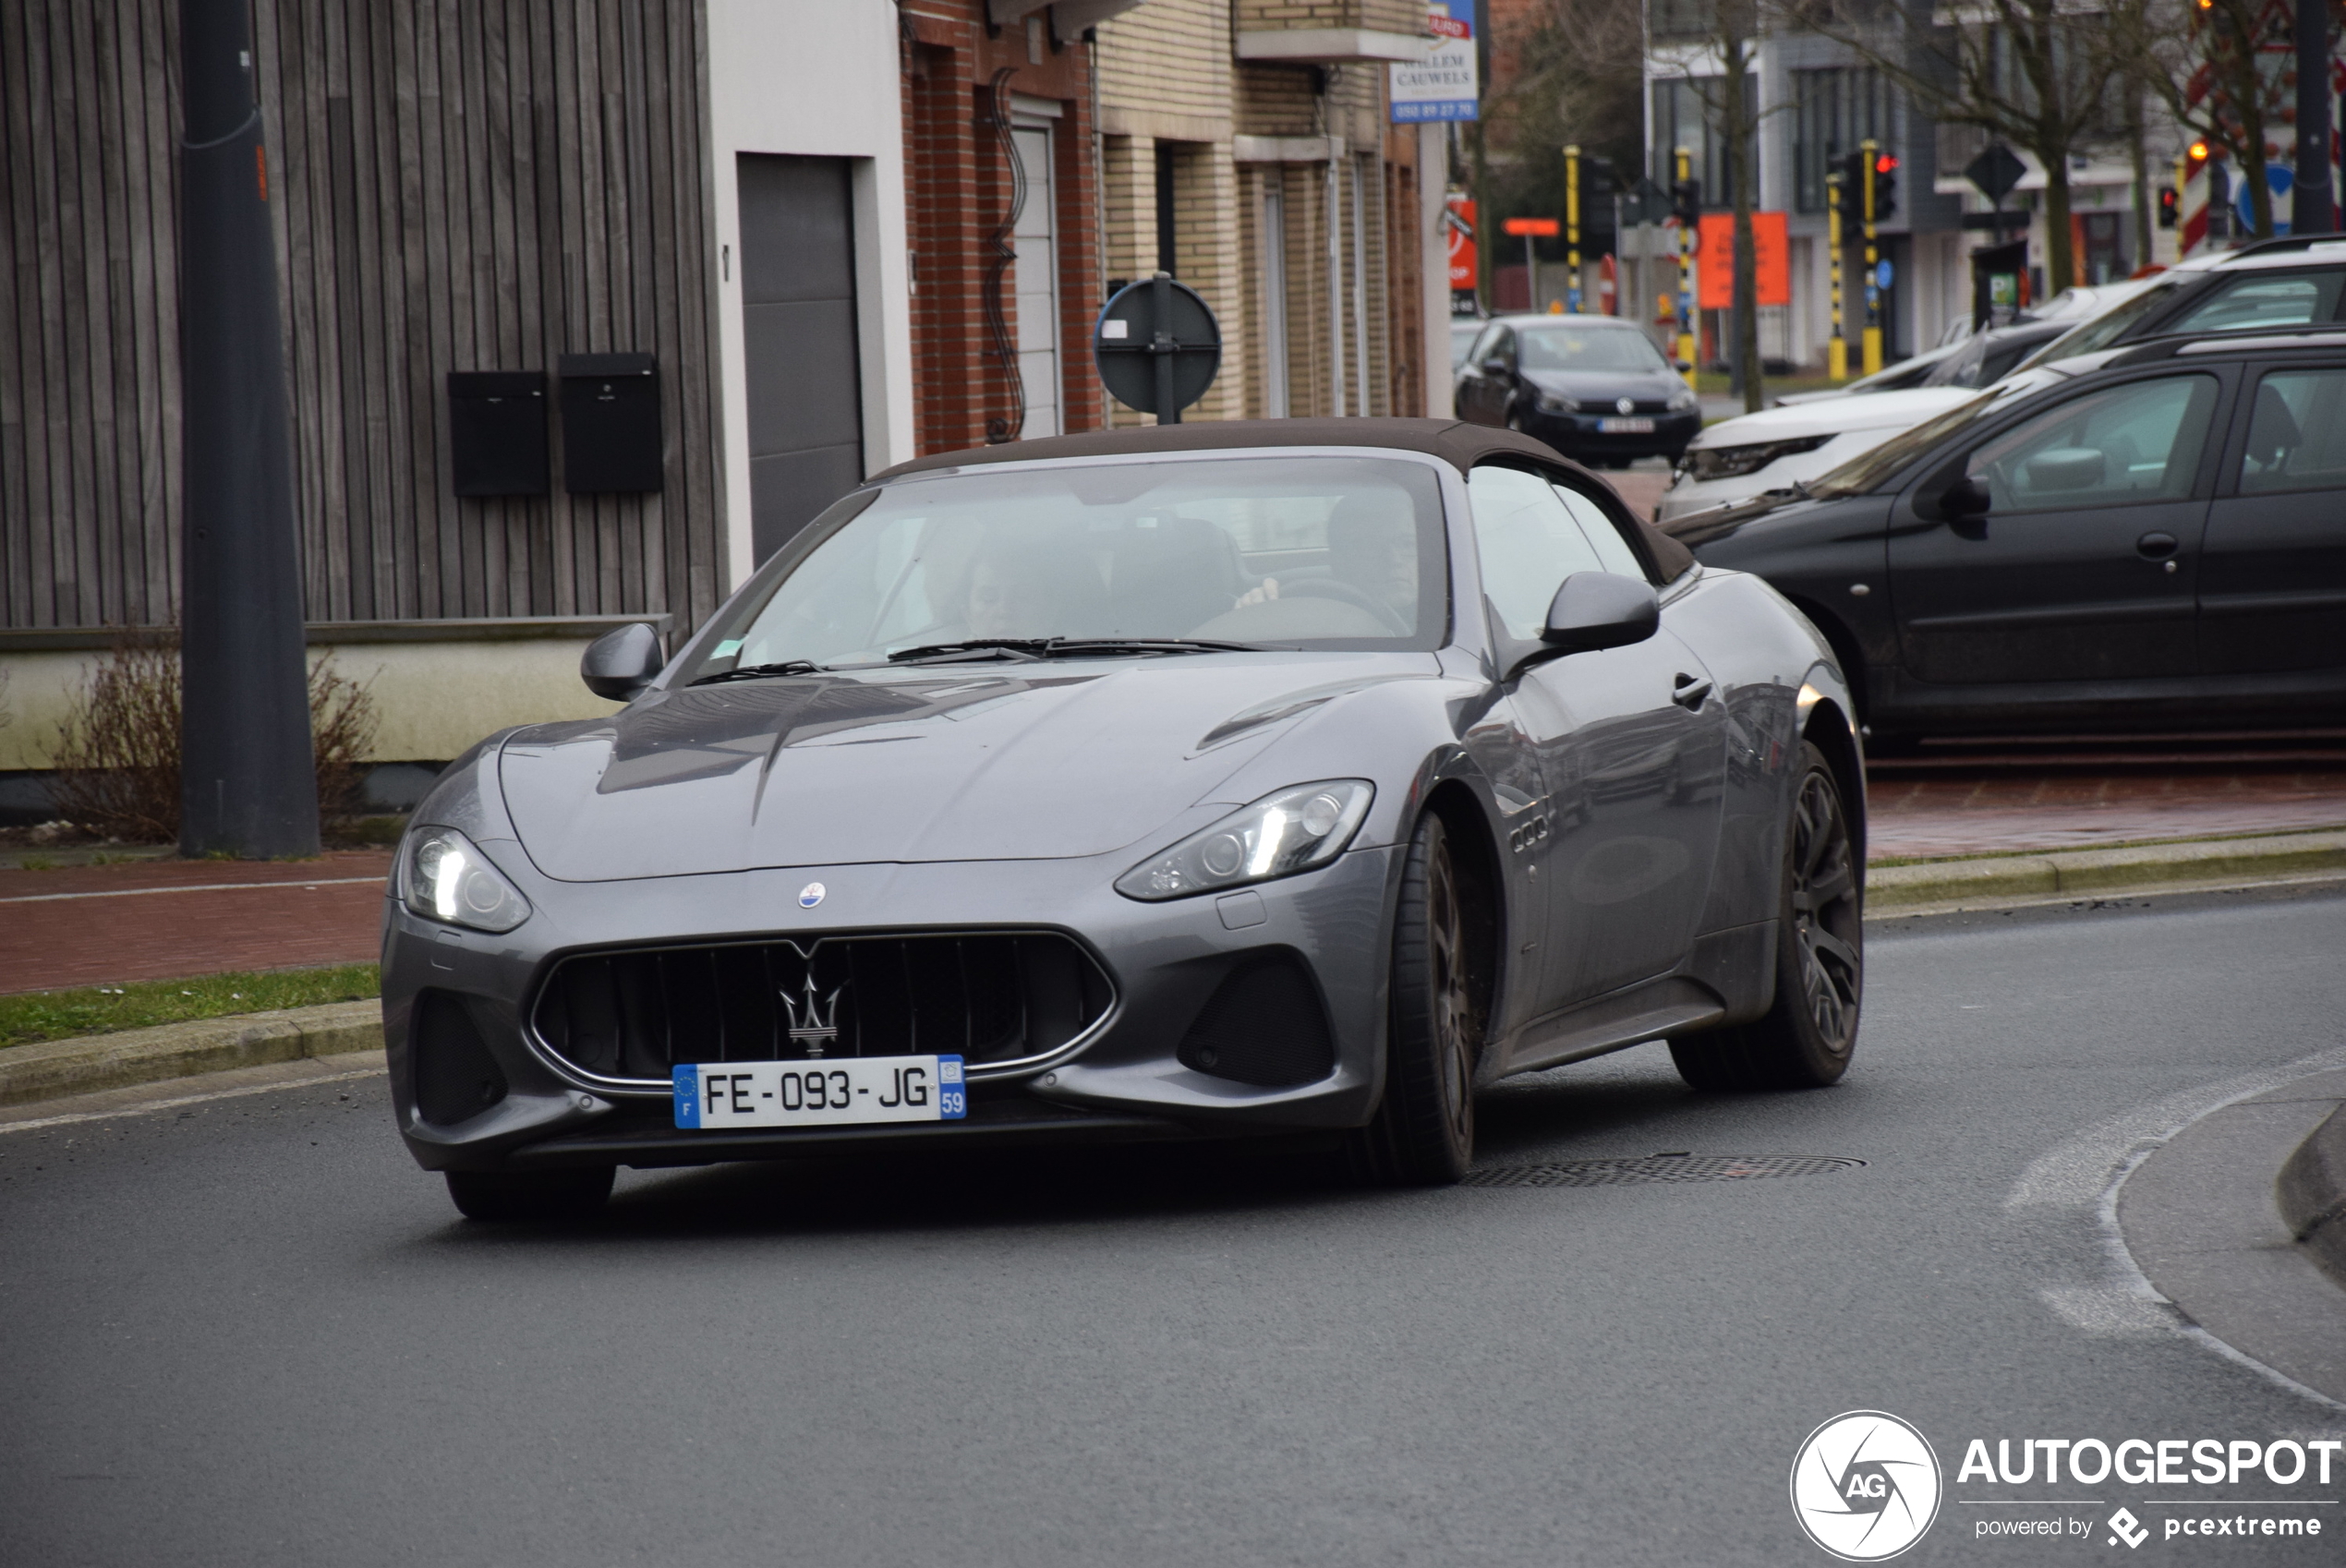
<box><xmin>1354</xmin><ymin>814</ymin><xmax>1487</xmax><ymax>1186</ymax></box>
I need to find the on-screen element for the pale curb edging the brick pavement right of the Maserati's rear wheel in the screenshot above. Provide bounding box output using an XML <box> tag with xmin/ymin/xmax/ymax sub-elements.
<box><xmin>1865</xmin><ymin>832</ymin><xmax>2346</xmax><ymax>911</ymax></box>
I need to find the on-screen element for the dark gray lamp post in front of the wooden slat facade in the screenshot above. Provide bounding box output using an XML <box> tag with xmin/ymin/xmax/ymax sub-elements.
<box><xmin>178</xmin><ymin>0</ymin><xmax>319</xmax><ymax>860</ymax></box>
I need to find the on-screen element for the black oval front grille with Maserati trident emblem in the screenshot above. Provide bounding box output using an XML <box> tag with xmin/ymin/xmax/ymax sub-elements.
<box><xmin>533</xmin><ymin>931</ymin><xmax>1115</xmax><ymax>1083</ymax></box>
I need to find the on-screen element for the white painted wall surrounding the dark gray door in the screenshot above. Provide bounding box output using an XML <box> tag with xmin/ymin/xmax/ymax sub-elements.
<box><xmin>707</xmin><ymin>0</ymin><xmax>913</xmax><ymax>586</ymax></box>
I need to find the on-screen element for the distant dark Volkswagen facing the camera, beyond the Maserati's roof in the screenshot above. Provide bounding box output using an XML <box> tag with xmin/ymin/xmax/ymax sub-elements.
<box><xmin>1455</xmin><ymin>314</ymin><xmax>1703</xmax><ymax>469</ymax></box>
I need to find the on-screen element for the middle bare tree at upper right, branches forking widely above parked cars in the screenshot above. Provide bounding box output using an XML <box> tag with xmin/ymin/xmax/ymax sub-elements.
<box><xmin>1787</xmin><ymin>0</ymin><xmax>2148</xmax><ymax>293</ymax></box>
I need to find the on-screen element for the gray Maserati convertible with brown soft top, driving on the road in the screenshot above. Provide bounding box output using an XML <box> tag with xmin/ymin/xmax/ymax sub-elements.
<box><xmin>382</xmin><ymin>419</ymin><xmax>1865</xmax><ymax>1219</ymax></box>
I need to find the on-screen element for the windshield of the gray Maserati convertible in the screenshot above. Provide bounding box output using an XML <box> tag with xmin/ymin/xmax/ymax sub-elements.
<box><xmin>687</xmin><ymin>457</ymin><xmax>1447</xmax><ymax>680</ymax></box>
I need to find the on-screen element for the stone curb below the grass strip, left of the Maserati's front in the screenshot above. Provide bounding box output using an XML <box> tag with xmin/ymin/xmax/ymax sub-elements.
<box><xmin>0</xmin><ymin>1001</ymin><xmax>382</xmax><ymax>1106</ymax></box>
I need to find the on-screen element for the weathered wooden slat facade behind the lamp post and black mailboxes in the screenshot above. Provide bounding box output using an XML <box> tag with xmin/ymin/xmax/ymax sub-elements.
<box><xmin>0</xmin><ymin>0</ymin><xmax>725</xmax><ymax>628</ymax></box>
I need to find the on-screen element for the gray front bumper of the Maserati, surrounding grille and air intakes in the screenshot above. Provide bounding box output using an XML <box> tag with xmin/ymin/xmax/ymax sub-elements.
<box><xmin>382</xmin><ymin>841</ymin><xmax>1398</xmax><ymax>1170</ymax></box>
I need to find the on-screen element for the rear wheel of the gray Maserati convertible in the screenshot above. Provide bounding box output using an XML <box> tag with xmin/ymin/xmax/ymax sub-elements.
<box><xmin>1670</xmin><ymin>741</ymin><xmax>1865</xmax><ymax>1090</ymax></box>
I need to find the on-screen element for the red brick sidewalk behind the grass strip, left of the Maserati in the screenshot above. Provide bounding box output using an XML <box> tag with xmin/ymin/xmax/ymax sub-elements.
<box><xmin>0</xmin><ymin>849</ymin><xmax>392</xmax><ymax>994</ymax></box>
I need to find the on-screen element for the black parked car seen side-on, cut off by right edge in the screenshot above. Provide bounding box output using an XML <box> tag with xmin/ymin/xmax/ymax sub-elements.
<box><xmin>1668</xmin><ymin>328</ymin><xmax>2346</xmax><ymax>741</ymax></box>
